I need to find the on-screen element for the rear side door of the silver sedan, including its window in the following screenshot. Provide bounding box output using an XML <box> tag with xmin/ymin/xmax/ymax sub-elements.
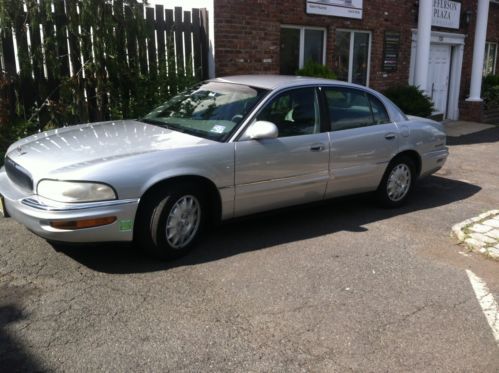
<box><xmin>323</xmin><ymin>87</ymin><xmax>399</xmax><ymax>197</ymax></box>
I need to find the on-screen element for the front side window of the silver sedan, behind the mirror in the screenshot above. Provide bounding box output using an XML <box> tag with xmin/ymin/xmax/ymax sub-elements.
<box><xmin>256</xmin><ymin>88</ymin><xmax>320</xmax><ymax>137</ymax></box>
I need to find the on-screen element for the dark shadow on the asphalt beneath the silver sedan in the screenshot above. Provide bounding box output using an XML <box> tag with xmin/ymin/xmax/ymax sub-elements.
<box><xmin>52</xmin><ymin>176</ymin><xmax>481</xmax><ymax>274</ymax></box>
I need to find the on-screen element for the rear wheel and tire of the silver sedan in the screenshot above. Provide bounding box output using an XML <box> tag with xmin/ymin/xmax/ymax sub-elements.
<box><xmin>376</xmin><ymin>156</ymin><xmax>417</xmax><ymax>208</ymax></box>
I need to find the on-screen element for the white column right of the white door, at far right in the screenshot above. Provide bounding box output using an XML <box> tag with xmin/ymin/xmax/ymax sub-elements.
<box><xmin>466</xmin><ymin>0</ymin><xmax>489</xmax><ymax>101</ymax></box>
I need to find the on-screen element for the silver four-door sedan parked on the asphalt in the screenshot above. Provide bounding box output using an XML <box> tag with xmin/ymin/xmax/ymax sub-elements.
<box><xmin>0</xmin><ymin>75</ymin><xmax>448</xmax><ymax>258</ymax></box>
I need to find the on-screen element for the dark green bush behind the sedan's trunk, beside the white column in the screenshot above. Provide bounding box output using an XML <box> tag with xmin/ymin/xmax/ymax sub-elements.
<box><xmin>383</xmin><ymin>85</ymin><xmax>434</xmax><ymax>117</ymax></box>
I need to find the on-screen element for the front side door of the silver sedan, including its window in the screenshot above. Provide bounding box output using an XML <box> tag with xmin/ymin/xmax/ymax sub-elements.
<box><xmin>235</xmin><ymin>87</ymin><xmax>329</xmax><ymax>216</ymax></box>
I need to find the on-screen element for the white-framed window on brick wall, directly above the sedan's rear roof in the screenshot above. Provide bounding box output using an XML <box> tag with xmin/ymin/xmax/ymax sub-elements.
<box><xmin>334</xmin><ymin>30</ymin><xmax>371</xmax><ymax>86</ymax></box>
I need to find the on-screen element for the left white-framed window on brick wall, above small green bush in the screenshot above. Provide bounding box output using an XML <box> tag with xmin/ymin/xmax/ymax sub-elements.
<box><xmin>280</xmin><ymin>26</ymin><xmax>326</xmax><ymax>75</ymax></box>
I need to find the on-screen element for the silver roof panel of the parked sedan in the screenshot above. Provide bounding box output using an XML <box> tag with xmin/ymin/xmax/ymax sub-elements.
<box><xmin>212</xmin><ymin>74</ymin><xmax>354</xmax><ymax>90</ymax></box>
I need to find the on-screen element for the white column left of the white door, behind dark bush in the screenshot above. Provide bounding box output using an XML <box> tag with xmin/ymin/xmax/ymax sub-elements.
<box><xmin>414</xmin><ymin>0</ymin><xmax>433</xmax><ymax>94</ymax></box>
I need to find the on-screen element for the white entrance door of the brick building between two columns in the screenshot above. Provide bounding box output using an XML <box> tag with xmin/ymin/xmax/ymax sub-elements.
<box><xmin>427</xmin><ymin>44</ymin><xmax>451</xmax><ymax>118</ymax></box>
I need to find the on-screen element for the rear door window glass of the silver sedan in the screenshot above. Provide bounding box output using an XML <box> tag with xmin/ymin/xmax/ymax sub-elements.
<box><xmin>325</xmin><ymin>87</ymin><xmax>375</xmax><ymax>131</ymax></box>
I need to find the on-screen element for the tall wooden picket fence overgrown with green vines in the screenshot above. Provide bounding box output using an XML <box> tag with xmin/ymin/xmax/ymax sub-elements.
<box><xmin>0</xmin><ymin>0</ymin><xmax>209</xmax><ymax>129</ymax></box>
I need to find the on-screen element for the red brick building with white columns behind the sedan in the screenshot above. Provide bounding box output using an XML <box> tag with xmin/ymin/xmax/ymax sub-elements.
<box><xmin>213</xmin><ymin>0</ymin><xmax>499</xmax><ymax>120</ymax></box>
